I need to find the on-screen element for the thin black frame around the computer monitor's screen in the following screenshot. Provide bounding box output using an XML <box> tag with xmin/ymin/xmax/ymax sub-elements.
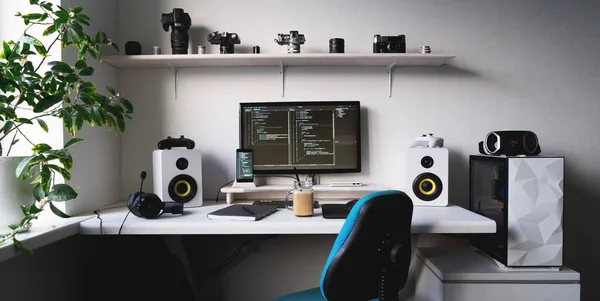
<box><xmin>238</xmin><ymin>100</ymin><xmax>362</xmax><ymax>175</ymax></box>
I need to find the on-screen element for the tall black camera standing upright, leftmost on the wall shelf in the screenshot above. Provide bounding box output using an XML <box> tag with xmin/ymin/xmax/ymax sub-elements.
<box><xmin>160</xmin><ymin>8</ymin><xmax>192</xmax><ymax>54</ymax></box>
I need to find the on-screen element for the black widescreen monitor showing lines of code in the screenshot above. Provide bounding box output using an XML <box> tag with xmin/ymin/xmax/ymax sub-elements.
<box><xmin>240</xmin><ymin>101</ymin><xmax>361</xmax><ymax>174</ymax></box>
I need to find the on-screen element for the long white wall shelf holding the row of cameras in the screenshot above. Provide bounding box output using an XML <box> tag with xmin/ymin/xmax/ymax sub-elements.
<box><xmin>104</xmin><ymin>53</ymin><xmax>454</xmax><ymax>68</ymax></box>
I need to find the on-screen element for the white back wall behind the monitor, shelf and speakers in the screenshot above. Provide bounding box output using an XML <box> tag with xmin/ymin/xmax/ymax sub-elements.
<box><xmin>119</xmin><ymin>0</ymin><xmax>600</xmax><ymax>300</ymax></box>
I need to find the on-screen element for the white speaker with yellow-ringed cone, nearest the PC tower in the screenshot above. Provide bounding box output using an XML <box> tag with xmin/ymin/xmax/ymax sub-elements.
<box><xmin>405</xmin><ymin>147</ymin><xmax>448</xmax><ymax>207</ymax></box>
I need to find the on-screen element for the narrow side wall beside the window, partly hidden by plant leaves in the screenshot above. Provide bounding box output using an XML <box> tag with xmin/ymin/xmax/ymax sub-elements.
<box><xmin>61</xmin><ymin>0</ymin><xmax>125</xmax><ymax>215</ymax></box>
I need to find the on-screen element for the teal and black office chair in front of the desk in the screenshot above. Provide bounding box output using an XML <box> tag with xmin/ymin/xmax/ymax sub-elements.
<box><xmin>275</xmin><ymin>190</ymin><xmax>413</xmax><ymax>301</ymax></box>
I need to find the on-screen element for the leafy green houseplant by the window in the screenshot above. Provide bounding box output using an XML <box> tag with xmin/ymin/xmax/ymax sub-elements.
<box><xmin>0</xmin><ymin>0</ymin><xmax>133</xmax><ymax>252</ymax></box>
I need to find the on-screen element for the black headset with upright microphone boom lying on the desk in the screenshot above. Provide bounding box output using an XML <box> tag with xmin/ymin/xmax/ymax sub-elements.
<box><xmin>127</xmin><ymin>171</ymin><xmax>183</xmax><ymax>218</ymax></box>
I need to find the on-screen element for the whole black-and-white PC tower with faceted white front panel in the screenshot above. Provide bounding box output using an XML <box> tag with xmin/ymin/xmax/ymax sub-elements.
<box><xmin>469</xmin><ymin>155</ymin><xmax>564</xmax><ymax>267</ymax></box>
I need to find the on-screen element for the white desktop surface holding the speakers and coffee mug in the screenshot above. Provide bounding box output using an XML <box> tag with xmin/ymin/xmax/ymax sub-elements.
<box><xmin>79</xmin><ymin>202</ymin><xmax>496</xmax><ymax>235</ymax></box>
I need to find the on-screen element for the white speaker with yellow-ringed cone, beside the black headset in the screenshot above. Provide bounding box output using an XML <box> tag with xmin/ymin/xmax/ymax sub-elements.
<box><xmin>152</xmin><ymin>149</ymin><xmax>202</xmax><ymax>207</ymax></box>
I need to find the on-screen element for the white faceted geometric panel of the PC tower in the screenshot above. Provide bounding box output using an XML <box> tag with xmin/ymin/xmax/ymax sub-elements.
<box><xmin>507</xmin><ymin>158</ymin><xmax>564</xmax><ymax>266</ymax></box>
